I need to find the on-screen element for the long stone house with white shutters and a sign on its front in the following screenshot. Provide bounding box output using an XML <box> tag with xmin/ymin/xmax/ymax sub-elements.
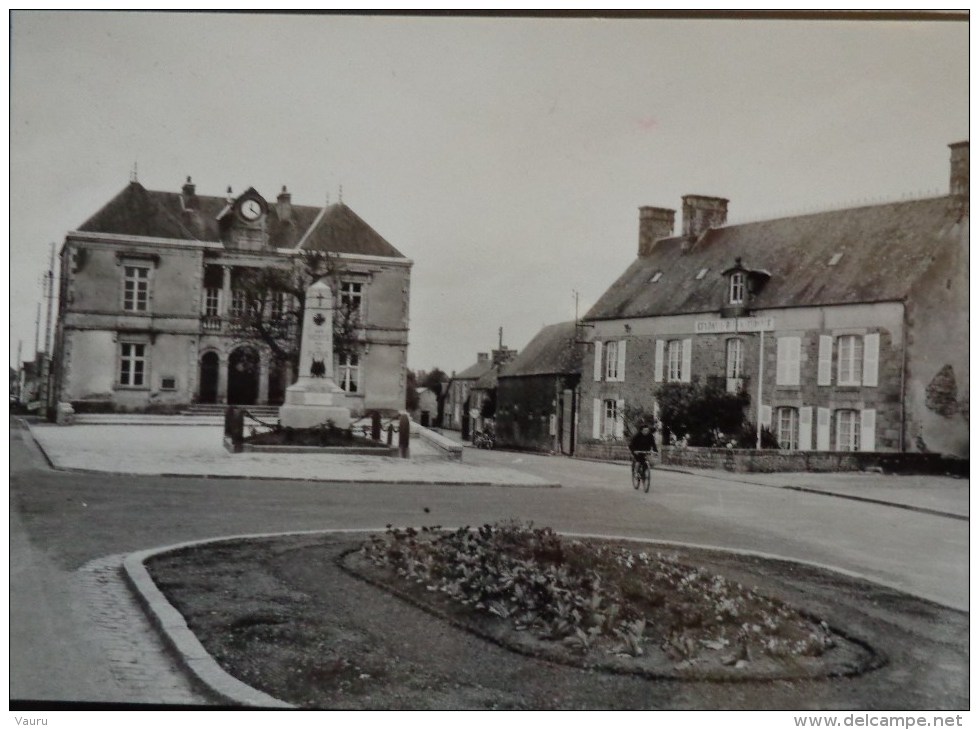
<box><xmin>578</xmin><ymin>142</ymin><xmax>969</xmax><ymax>456</ymax></box>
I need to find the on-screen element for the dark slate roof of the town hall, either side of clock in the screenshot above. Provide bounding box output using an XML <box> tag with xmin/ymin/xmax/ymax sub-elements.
<box><xmin>78</xmin><ymin>182</ymin><xmax>404</xmax><ymax>258</ymax></box>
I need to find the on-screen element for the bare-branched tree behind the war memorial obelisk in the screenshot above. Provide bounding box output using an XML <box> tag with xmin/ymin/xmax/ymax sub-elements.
<box><xmin>229</xmin><ymin>251</ymin><xmax>362</xmax><ymax>373</ymax></box>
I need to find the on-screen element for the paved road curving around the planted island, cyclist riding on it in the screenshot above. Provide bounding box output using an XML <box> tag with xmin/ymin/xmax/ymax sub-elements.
<box><xmin>10</xmin><ymin>420</ymin><xmax>968</xmax><ymax>703</ymax></box>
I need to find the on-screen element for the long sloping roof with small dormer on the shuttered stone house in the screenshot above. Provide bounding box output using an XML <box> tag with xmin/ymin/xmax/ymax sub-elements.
<box><xmin>585</xmin><ymin>197</ymin><xmax>961</xmax><ymax>319</ymax></box>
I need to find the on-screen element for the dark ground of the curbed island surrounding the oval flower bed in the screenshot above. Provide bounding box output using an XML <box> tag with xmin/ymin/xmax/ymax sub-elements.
<box><xmin>147</xmin><ymin>536</ymin><xmax>969</xmax><ymax>710</ymax></box>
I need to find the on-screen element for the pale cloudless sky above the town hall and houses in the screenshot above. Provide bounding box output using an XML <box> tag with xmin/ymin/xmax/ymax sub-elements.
<box><xmin>9</xmin><ymin>11</ymin><xmax>969</xmax><ymax>373</ymax></box>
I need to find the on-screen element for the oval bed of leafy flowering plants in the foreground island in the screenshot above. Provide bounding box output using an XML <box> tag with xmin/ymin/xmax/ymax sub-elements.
<box><xmin>361</xmin><ymin>523</ymin><xmax>872</xmax><ymax>678</ymax></box>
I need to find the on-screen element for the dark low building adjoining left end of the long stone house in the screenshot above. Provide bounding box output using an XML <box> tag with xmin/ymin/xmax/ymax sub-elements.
<box><xmin>496</xmin><ymin>322</ymin><xmax>584</xmax><ymax>454</ymax></box>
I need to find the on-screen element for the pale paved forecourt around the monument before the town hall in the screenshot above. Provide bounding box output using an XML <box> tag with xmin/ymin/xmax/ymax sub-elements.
<box><xmin>28</xmin><ymin>423</ymin><xmax>560</xmax><ymax>487</ymax></box>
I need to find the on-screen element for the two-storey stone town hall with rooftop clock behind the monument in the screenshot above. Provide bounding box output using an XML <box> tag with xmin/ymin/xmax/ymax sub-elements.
<box><xmin>55</xmin><ymin>178</ymin><xmax>412</xmax><ymax>411</ymax></box>
